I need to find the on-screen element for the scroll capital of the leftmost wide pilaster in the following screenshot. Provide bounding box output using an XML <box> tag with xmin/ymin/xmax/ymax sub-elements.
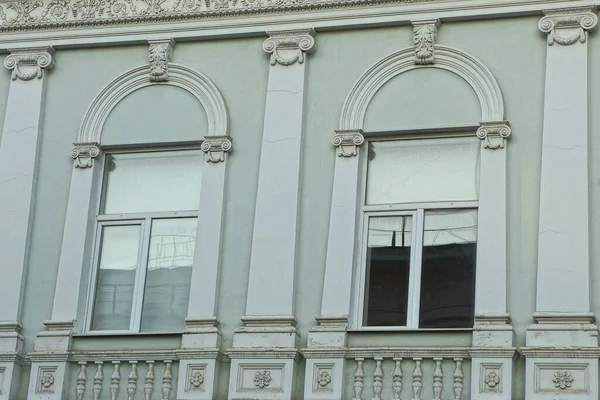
<box><xmin>4</xmin><ymin>47</ymin><xmax>55</xmax><ymax>81</ymax></box>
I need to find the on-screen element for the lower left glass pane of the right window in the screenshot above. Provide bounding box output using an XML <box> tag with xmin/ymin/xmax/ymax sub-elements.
<box><xmin>364</xmin><ymin>215</ymin><xmax>412</xmax><ymax>326</ymax></box>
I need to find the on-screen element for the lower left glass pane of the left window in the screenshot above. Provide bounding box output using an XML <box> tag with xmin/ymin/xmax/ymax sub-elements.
<box><xmin>91</xmin><ymin>225</ymin><xmax>141</xmax><ymax>330</ymax></box>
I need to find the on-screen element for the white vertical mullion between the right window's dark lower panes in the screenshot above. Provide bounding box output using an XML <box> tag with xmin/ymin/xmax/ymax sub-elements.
<box><xmin>407</xmin><ymin>208</ymin><xmax>425</xmax><ymax>328</ymax></box>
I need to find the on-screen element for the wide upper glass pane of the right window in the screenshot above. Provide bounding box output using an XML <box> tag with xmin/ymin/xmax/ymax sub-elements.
<box><xmin>367</xmin><ymin>137</ymin><xmax>480</xmax><ymax>204</ymax></box>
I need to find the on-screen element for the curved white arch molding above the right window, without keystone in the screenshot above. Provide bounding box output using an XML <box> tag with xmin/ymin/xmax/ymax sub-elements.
<box><xmin>339</xmin><ymin>45</ymin><xmax>504</xmax><ymax>130</ymax></box>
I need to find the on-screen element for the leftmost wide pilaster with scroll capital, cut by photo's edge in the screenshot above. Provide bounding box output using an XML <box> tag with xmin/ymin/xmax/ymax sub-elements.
<box><xmin>0</xmin><ymin>47</ymin><xmax>54</xmax><ymax>400</ymax></box>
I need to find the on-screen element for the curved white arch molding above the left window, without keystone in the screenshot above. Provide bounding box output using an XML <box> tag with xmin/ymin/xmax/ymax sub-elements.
<box><xmin>77</xmin><ymin>63</ymin><xmax>229</xmax><ymax>143</ymax></box>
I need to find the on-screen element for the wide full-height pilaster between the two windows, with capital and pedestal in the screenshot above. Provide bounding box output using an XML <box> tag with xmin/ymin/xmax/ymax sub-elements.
<box><xmin>229</xmin><ymin>30</ymin><xmax>314</xmax><ymax>400</ymax></box>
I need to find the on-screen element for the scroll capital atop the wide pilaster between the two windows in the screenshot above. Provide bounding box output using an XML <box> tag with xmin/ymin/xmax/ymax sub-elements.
<box><xmin>263</xmin><ymin>29</ymin><xmax>315</xmax><ymax>67</ymax></box>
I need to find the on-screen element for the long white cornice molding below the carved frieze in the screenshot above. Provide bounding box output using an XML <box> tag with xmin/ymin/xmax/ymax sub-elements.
<box><xmin>0</xmin><ymin>0</ymin><xmax>600</xmax><ymax>49</ymax></box>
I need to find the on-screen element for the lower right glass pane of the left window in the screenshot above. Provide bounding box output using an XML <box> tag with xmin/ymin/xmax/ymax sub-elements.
<box><xmin>141</xmin><ymin>218</ymin><xmax>197</xmax><ymax>332</ymax></box>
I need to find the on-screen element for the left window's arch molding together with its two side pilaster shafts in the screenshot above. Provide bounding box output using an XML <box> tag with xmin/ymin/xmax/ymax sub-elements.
<box><xmin>45</xmin><ymin>63</ymin><xmax>232</xmax><ymax>332</ymax></box>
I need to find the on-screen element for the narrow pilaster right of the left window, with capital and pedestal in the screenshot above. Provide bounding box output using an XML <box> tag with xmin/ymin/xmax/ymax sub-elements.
<box><xmin>177</xmin><ymin>136</ymin><xmax>232</xmax><ymax>400</ymax></box>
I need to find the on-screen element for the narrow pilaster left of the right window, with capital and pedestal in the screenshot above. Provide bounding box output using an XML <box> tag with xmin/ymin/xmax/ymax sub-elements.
<box><xmin>302</xmin><ymin>130</ymin><xmax>365</xmax><ymax>400</ymax></box>
